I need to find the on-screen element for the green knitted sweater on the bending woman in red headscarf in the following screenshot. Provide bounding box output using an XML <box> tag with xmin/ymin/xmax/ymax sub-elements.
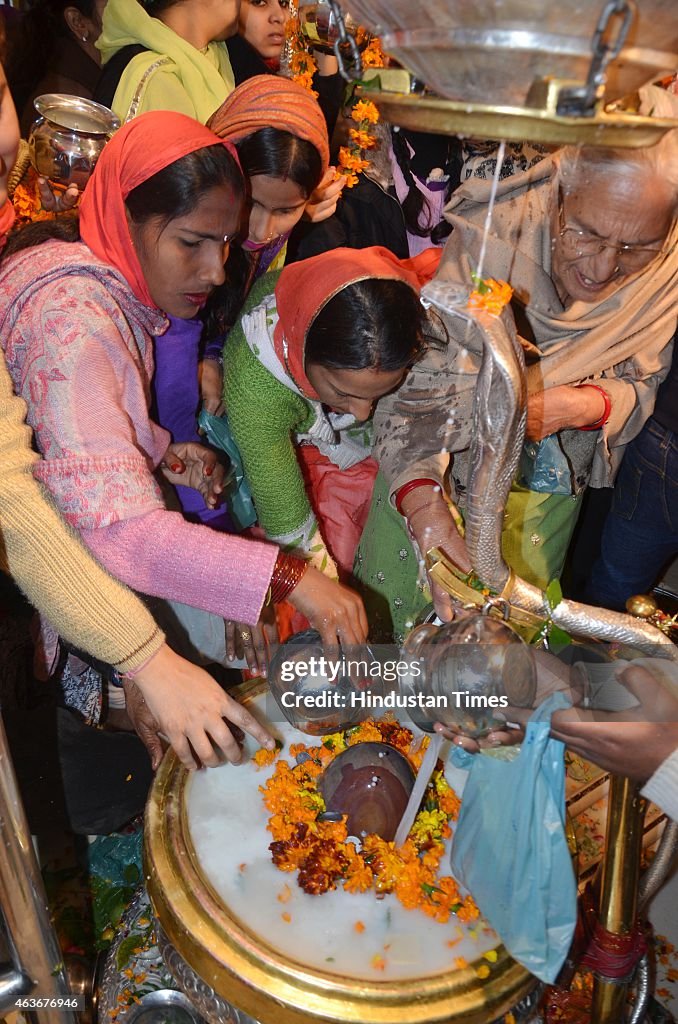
<box><xmin>223</xmin><ymin>271</ymin><xmax>314</xmax><ymax>547</ymax></box>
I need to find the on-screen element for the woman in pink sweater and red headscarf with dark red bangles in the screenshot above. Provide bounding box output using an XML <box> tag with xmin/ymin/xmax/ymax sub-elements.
<box><xmin>0</xmin><ymin>112</ymin><xmax>366</xmax><ymax>704</ymax></box>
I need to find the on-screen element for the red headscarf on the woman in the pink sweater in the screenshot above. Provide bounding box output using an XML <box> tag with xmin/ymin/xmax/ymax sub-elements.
<box><xmin>80</xmin><ymin>111</ymin><xmax>240</xmax><ymax>308</ymax></box>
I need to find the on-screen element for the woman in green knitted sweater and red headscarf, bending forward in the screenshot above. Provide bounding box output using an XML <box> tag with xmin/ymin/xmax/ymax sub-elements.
<box><xmin>224</xmin><ymin>247</ymin><xmax>446</xmax><ymax>614</ymax></box>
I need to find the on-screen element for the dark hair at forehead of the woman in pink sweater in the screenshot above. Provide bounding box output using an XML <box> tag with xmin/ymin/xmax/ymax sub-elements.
<box><xmin>125</xmin><ymin>143</ymin><xmax>245</xmax><ymax>227</ymax></box>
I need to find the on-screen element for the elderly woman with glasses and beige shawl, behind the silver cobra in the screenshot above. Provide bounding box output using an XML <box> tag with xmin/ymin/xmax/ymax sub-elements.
<box><xmin>356</xmin><ymin>140</ymin><xmax>678</xmax><ymax>636</ymax></box>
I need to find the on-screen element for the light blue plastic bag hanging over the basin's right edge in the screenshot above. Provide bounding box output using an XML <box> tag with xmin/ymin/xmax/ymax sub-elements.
<box><xmin>452</xmin><ymin>693</ymin><xmax>577</xmax><ymax>984</ymax></box>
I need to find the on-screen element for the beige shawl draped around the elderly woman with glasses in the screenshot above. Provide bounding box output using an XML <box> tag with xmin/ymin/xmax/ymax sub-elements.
<box><xmin>438</xmin><ymin>157</ymin><xmax>678</xmax><ymax>486</ymax></box>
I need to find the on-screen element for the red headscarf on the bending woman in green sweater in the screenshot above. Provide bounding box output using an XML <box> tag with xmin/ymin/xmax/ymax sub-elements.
<box><xmin>273</xmin><ymin>246</ymin><xmax>442</xmax><ymax>399</ymax></box>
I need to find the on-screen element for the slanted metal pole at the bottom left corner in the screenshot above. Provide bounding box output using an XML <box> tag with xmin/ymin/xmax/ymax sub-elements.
<box><xmin>0</xmin><ymin>716</ymin><xmax>76</xmax><ymax>1024</ymax></box>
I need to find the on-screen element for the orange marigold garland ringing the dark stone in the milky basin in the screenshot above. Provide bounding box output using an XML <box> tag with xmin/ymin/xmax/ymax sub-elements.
<box><xmin>255</xmin><ymin>718</ymin><xmax>478</xmax><ymax>924</ymax></box>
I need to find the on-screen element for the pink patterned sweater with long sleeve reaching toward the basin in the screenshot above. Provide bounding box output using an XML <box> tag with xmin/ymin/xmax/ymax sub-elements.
<box><xmin>0</xmin><ymin>242</ymin><xmax>278</xmax><ymax>623</ymax></box>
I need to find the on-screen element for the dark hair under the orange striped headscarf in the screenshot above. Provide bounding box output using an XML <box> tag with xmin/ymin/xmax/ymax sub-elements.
<box><xmin>237</xmin><ymin>128</ymin><xmax>323</xmax><ymax>198</ymax></box>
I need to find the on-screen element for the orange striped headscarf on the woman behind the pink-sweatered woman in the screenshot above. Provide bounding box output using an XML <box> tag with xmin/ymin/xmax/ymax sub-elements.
<box><xmin>207</xmin><ymin>75</ymin><xmax>330</xmax><ymax>174</ymax></box>
